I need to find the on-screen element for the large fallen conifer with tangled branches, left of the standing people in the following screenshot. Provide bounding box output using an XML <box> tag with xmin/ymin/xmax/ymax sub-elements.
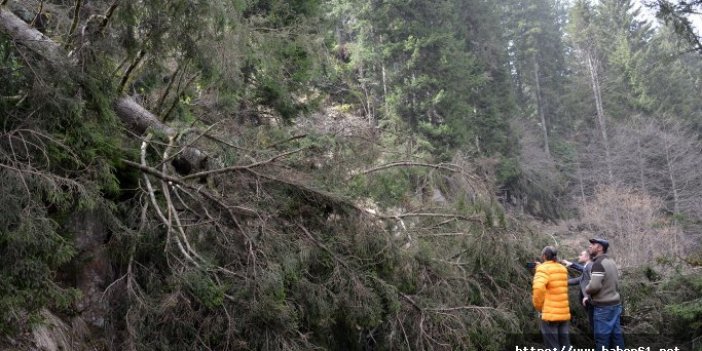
<box><xmin>0</xmin><ymin>1</ymin><xmax>544</xmax><ymax>350</ymax></box>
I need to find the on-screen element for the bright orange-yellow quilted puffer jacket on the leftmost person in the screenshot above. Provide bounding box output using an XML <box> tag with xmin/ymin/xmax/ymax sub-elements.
<box><xmin>532</xmin><ymin>261</ymin><xmax>570</xmax><ymax>322</ymax></box>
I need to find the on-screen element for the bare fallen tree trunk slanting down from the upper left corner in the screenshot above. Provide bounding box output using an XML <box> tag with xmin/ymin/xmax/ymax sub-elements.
<box><xmin>0</xmin><ymin>6</ymin><xmax>202</xmax><ymax>164</ymax></box>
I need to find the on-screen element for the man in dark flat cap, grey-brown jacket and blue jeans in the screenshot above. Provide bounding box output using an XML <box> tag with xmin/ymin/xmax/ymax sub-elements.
<box><xmin>585</xmin><ymin>239</ymin><xmax>624</xmax><ymax>350</ymax></box>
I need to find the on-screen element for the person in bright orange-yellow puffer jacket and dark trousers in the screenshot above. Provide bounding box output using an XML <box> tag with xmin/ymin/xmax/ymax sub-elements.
<box><xmin>532</xmin><ymin>246</ymin><xmax>570</xmax><ymax>349</ymax></box>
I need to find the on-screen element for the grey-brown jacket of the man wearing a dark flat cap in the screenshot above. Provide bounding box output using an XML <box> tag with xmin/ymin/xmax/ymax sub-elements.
<box><xmin>585</xmin><ymin>254</ymin><xmax>621</xmax><ymax>306</ymax></box>
